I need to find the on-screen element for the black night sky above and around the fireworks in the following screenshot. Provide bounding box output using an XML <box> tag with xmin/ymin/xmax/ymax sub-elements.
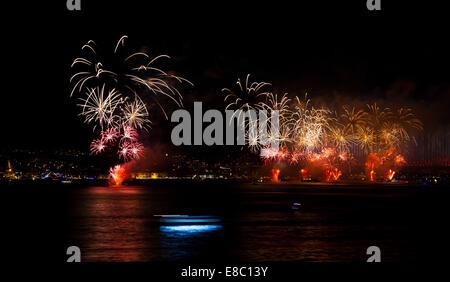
<box><xmin>1</xmin><ymin>0</ymin><xmax>450</xmax><ymax>149</ymax></box>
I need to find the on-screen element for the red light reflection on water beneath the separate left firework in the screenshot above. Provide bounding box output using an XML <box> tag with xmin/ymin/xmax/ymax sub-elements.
<box><xmin>72</xmin><ymin>187</ymin><xmax>153</xmax><ymax>261</ymax></box>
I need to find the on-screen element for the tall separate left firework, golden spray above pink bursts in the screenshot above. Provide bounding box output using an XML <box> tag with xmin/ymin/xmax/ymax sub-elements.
<box><xmin>70</xmin><ymin>35</ymin><xmax>191</xmax><ymax>182</ymax></box>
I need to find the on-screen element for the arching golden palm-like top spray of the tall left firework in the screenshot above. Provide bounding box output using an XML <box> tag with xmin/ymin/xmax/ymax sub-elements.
<box><xmin>70</xmin><ymin>35</ymin><xmax>192</xmax><ymax>108</ymax></box>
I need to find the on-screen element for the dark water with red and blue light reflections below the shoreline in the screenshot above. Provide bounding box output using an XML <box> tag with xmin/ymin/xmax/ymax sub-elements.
<box><xmin>4</xmin><ymin>183</ymin><xmax>448</xmax><ymax>262</ymax></box>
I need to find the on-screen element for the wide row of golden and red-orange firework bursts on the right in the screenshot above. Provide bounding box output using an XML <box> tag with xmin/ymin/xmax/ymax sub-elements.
<box><xmin>224</xmin><ymin>75</ymin><xmax>422</xmax><ymax>181</ymax></box>
